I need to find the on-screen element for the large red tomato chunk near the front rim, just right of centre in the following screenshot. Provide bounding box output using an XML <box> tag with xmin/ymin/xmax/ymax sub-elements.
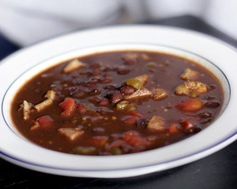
<box><xmin>124</xmin><ymin>131</ymin><xmax>149</xmax><ymax>149</ymax></box>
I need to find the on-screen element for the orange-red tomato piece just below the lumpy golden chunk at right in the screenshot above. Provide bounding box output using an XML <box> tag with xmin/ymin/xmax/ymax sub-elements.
<box><xmin>176</xmin><ymin>99</ymin><xmax>203</xmax><ymax>112</ymax></box>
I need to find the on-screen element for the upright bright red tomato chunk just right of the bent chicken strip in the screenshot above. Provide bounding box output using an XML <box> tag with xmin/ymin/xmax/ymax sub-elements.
<box><xmin>59</xmin><ymin>98</ymin><xmax>76</xmax><ymax>117</ymax></box>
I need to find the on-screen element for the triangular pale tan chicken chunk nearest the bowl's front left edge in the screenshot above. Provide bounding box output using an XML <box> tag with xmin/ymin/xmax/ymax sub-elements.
<box><xmin>58</xmin><ymin>128</ymin><xmax>84</xmax><ymax>142</ymax></box>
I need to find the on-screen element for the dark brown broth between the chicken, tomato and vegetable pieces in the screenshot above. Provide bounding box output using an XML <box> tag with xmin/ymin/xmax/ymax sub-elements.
<box><xmin>11</xmin><ymin>51</ymin><xmax>223</xmax><ymax>155</ymax></box>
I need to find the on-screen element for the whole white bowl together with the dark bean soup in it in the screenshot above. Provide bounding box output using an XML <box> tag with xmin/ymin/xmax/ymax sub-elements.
<box><xmin>0</xmin><ymin>26</ymin><xmax>237</xmax><ymax>178</ymax></box>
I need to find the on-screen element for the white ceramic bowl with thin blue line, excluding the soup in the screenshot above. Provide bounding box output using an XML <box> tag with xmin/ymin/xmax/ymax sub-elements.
<box><xmin>0</xmin><ymin>26</ymin><xmax>237</xmax><ymax>178</ymax></box>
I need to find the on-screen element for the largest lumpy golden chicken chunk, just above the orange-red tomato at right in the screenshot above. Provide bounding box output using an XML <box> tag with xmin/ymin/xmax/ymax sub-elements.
<box><xmin>175</xmin><ymin>81</ymin><xmax>208</xmax><ymax>98</ymax></box>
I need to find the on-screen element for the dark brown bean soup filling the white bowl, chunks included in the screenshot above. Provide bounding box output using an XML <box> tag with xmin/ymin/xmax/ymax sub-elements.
<box><xmin>11</xmin><ymin>51</ymin><xmax>223</xmax><ymax>155</ymax></box>
